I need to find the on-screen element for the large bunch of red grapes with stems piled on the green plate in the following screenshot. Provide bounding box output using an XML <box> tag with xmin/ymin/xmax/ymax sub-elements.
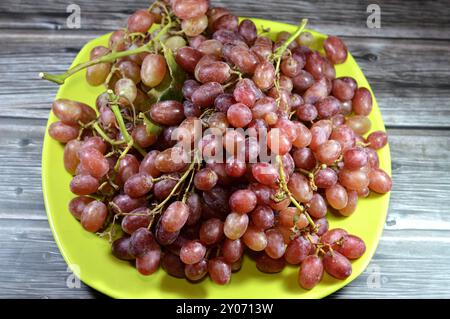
<box><xmin>44</xmin><ymin>0</ymin><xmax>392</xmax><ymax>289</ymax></box>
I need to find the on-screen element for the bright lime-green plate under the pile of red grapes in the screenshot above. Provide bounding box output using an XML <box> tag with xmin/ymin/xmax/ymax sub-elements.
<box><xmin>42</xmin><ymin>19</ymin><xmax>391</xmax><ymax>298</ymax></box>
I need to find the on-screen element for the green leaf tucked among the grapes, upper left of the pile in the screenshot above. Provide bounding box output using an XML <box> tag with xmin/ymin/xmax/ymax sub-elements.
<box><xmin>148</xmin><ymin>43</ymin><xmax>186</xmax><ymax>103</ymax></box>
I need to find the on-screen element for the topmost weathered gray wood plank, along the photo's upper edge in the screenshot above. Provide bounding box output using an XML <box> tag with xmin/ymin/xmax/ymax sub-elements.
<box><xmin>0</xmin><ymin>0</ymin><xmax>450</xmax><ymax>39</ymax></box>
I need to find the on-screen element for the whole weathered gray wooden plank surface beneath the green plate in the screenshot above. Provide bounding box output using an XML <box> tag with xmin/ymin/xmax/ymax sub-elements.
<box><xmin>0</xmin><ymin>0</ymin><xmax>450</xmax><ymax>298</ymax></box>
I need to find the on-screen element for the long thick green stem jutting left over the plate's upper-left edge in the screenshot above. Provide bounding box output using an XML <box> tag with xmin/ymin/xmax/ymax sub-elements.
<box><xmin>39</xmin><ymin>22</ymin><xmax>175</xmax><ymax>85</ymax></box>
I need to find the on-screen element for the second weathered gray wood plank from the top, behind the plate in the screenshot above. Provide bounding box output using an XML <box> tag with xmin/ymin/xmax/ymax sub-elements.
<box><xmin>0</xmin><ymin>31</ymin><xmax>450</xmax><ymax>128</ymax></box>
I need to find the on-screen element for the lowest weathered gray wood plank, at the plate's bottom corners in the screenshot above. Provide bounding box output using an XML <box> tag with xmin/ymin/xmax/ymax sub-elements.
<box><xmin>0</xmin><ymin>219</ymin><xmax>450</xmax><ymax>298</ymax></box>
